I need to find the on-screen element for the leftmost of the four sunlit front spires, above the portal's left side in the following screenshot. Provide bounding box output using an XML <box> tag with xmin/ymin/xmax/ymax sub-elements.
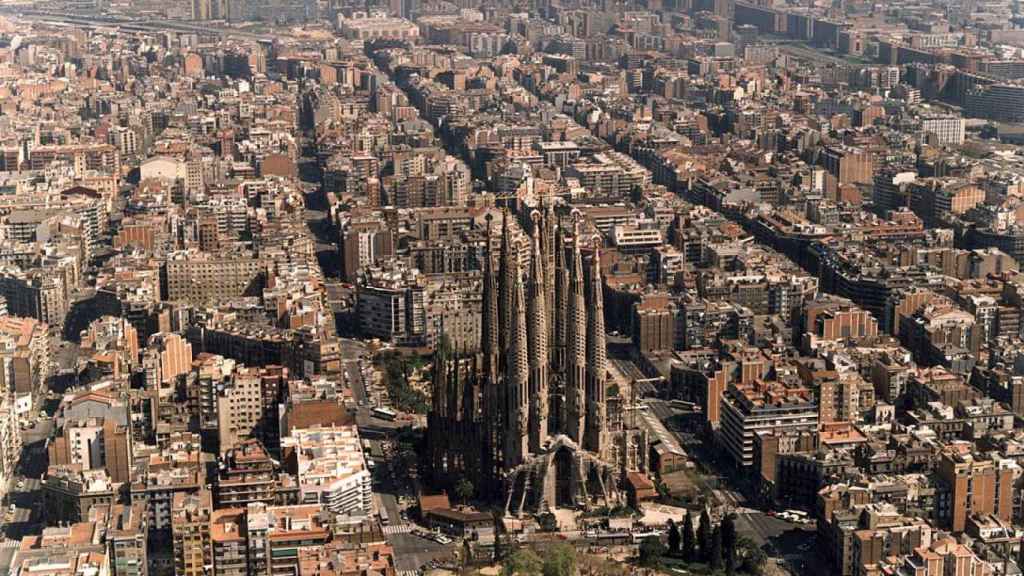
<box><xmin>503</xmin><ymin>251</ymin><xmax>529</xmax><ymax>470</ymax></box>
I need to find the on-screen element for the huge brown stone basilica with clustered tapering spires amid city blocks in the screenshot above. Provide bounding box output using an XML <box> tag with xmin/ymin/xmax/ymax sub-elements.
<box><xmin>427</xmin><ymin>208</ymin><xmax>648</xmax><ymax>515</ymax></box>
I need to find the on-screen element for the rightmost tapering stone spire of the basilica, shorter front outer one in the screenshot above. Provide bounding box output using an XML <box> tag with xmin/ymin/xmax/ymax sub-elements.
<box><xmin>585</xmin><ymin>239</ymin><xmax>608</xmax><ymax>455</ymax></box>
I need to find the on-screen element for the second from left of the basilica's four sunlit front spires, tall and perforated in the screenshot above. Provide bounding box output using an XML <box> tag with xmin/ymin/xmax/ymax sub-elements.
<box><xmin>526</xmin><ymin>212</ymin><xmax>550</xmax><ymax>454</ymax></box>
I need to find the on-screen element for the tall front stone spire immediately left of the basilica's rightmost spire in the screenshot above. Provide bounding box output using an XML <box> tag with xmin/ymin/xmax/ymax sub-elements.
<box><xmin>565</xmin><ymin>212</ymin><xmax>587</xmax><ymax>444</ymax></box>
